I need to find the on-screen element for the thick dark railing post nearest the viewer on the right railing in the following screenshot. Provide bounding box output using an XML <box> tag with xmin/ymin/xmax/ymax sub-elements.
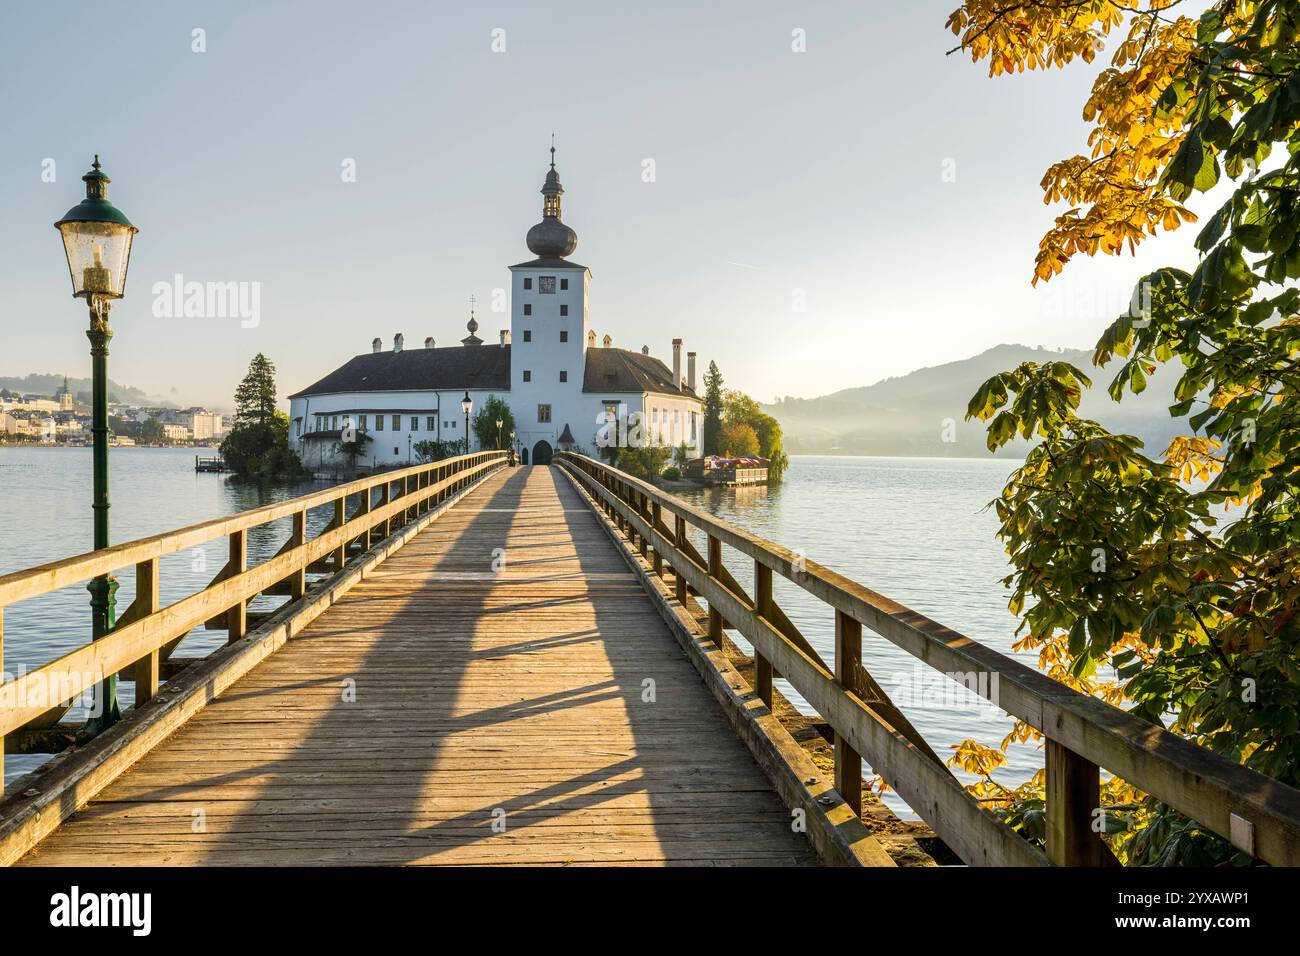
<box><xmin>1047</xmin><ymin>737</ymin><xmax>1113</xmax><ymax>866</ymax></box>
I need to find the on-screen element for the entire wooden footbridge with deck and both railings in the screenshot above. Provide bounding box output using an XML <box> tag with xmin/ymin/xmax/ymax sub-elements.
<box><xmin>0</xmin><ymin>453</ymin><xmax>1300</xmax><ymax>866</ymax></box>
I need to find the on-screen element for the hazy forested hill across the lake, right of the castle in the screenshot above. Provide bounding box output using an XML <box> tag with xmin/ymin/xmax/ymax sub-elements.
<box><xmin>763</xmin><ymin>345</ymin><xmax>1186</xmax><ymax>458</ymax></box>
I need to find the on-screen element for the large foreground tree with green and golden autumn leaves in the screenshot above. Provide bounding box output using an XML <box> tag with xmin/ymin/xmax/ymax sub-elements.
<box><xmin>949</xmin><ymin>0</ymin><xmax>1300</xmax><ymax>864</ymax></box>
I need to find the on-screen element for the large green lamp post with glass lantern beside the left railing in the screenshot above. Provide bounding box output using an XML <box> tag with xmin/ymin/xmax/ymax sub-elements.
<box><xmin>55</xmin><ymin>156</ymin><xmax>139</xmax><ymax>735</ymax></box>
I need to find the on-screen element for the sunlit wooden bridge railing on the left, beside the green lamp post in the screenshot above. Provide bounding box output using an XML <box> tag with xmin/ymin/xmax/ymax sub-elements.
<box><xmin>0</xmin><ymin>451</ymin><xmax>506</xmax><ymax>793</ymax></box>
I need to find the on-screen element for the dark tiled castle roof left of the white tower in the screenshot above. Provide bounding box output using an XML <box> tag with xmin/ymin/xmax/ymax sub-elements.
<box><xmin>290</xmin><ymin>345</ymin><xmax>509</xmax><ymax>398</ymax></box>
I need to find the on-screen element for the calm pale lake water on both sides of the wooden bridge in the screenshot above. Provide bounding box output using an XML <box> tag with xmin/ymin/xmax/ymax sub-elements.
<box><xmin>0</xmin><ymin>446</ymin><xmax>1043</xmax><ymax>812</ymax></box>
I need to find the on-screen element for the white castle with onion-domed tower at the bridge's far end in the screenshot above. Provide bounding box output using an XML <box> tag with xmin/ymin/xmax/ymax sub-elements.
<box><xmin>289</xmin><ymin>147</ymin><xmax>701</xmax><ymax>467</ymax></box>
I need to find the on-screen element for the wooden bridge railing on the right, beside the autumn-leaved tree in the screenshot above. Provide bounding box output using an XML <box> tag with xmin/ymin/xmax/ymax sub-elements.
<box><xmin>556</xmin><ymin>454</ymin><xmax>1300</xmax><ymax>866</ymax></box>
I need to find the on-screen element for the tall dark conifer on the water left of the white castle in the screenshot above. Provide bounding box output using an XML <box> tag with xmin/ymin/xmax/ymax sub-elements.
<box><xmin>221</xmin><ymin>352</ymin><xmax>307</xmax><ymax>481</ymax></box>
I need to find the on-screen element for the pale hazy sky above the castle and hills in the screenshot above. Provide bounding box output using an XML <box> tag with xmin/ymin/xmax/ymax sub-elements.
<box><xmin>0</xmin><ymin>0</ymin><xmax>1213</xmax><ymax>406</ymax></box>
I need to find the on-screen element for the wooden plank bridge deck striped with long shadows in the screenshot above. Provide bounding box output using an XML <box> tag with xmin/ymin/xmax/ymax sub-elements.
<box><xmin>21</xmin><ymin>467</ymin><xmax>816</xmax><ymax>866</ymax></box>
